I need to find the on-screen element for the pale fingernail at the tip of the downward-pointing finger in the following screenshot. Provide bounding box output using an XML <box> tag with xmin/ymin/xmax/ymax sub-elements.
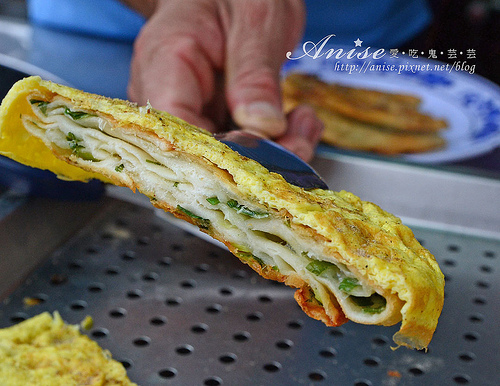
<box><xmin>233</xmin><ymin>102</ymin><xmax>286</xmax><ymax>137</ymax></box>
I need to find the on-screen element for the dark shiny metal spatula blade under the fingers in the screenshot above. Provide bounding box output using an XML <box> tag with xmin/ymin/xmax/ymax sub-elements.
<box><xmin>215</xmin><ymin>130</ymin><xmax>328</xmax><ymax>189</ymax></box>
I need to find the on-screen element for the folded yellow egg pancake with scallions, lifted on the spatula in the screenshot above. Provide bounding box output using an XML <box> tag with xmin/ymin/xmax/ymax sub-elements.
<box><xmin>0</xmin><ymin>77</ymin><xmax>444</xmax><ymax>348</ymax></box>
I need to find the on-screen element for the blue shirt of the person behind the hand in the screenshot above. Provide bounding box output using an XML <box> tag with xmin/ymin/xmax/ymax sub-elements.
<box><xmin>28</xmin><ymin>0</ymin><xmax>431</xmax><ymax>48</ymax></box>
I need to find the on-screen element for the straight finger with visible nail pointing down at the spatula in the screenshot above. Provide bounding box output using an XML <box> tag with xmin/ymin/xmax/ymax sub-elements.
<box><xmin>223</xmin><ymin>0</ymin><xmax>303</xmax><ymax>137</ymax></box>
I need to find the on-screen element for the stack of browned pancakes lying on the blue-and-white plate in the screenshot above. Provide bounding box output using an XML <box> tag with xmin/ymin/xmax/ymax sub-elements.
<box><xmin>283</xmin><ymin>73</ymin><xmax>447</xmax><ymax>155</ymax></box>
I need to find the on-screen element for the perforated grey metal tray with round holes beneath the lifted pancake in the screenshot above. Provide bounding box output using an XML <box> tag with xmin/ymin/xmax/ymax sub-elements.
<box><xmin>0</xmin><ymin>200</ymin><xmax>500</xmax><ymax>386</ymax></box>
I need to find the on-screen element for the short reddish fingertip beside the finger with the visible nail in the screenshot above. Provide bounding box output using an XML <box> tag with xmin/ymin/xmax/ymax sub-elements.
<box><xmin>276</xmin><ymin>105</ymin><xmax>323</xmax><ymax>162</ymax></box>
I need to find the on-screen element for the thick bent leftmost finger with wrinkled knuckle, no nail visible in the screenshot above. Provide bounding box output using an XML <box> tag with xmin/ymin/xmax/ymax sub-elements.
<box><xmin>128</xmin><ymin>2</ymin><xmax>222</xmax><ymax>131</ymax></box>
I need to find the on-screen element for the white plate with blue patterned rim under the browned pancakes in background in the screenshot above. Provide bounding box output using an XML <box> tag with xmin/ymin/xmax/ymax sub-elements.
<box><xmin>283</xmin><ymin>52</ymin><xmax>500</xmax><ymax>163</ymax></box>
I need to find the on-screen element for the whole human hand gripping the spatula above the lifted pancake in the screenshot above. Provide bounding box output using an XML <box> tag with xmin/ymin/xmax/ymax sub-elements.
<box><xmin>128</xmin><ymin>0</ymin><xmax>322</xmax><ymax>160</ymax></box>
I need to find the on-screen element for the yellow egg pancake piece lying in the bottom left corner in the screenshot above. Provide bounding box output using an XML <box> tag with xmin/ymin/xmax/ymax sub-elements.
<box><xmin>0</xmin><ymin>312</ymin><xmax>135</xmax><ymax>386</ymax></box>
